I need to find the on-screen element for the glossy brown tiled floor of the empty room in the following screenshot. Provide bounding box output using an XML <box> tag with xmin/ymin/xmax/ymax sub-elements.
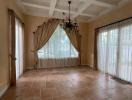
<box><xmin>0</xmin><ymin>67</ymin><xmax>132</xmax><ymax>100</ymax></box>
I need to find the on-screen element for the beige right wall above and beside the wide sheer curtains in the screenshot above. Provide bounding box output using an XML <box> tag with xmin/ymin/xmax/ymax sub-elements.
<box><xmin>87</xmin><ymin>2</ymin><xmax>132</xmax><ymax>67</ymax></box>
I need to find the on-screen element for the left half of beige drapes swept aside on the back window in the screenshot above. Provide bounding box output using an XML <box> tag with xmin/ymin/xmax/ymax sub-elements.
<box><xmin>34</xmin><ymin>19</ymin><xmax>61</xmax><ymax>68</ymax></box>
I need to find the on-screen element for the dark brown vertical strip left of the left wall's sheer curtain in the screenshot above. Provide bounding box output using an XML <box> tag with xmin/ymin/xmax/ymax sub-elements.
<box><xmin>8</xmin><ymin>9</ymin><xmax>16</xmax><ymax>85</ymax></box>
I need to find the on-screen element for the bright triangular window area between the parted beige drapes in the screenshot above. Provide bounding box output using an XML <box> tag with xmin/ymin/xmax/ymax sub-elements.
<box><xmin>38</xmin><ymin>26</ymin><xmax>78</xmax><ymax>59</ymax></box>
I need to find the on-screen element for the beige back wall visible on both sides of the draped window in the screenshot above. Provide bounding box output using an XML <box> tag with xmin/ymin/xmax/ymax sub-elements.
<box><xmin>25</xmin><ymin>15</ymin><xmax>88</xmax><ymax>69</ymax></box>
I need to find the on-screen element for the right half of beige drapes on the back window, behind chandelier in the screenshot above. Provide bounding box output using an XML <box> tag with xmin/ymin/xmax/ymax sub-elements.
<box><xmin>64</xmin><ymin>28</ymin><xmax>81</xmax><ymax>64</ymax></box>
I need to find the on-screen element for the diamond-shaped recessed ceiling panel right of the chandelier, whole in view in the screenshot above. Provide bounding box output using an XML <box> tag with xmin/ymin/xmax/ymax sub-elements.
<box><xmin>83</xmin><ymin>4</ymin><xmax>108</xmax><ymax>15</ymax></box>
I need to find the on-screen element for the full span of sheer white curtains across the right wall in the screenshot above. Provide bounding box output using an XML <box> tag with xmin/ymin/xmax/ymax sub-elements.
<box><xmin>97</xmin><ymin>19</ymin><xmax>132</xmax><ymax>82</ymax></box>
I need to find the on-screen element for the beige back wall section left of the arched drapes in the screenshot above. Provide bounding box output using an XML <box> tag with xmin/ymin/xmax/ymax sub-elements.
<box><xmin>25</xmin><ymin>15</ymin><xmax>48</xmax><ymax>68</ymax></box>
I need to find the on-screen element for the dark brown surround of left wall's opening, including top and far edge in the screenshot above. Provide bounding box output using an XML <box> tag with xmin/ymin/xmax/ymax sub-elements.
<box><xmin>8</xmin><ymin>8</ymin><xmax>25</xmax><ymax>86</ymax></box>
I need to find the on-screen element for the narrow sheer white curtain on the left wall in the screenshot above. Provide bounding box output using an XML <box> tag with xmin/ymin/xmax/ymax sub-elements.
<box><xmin>15</xmin><ymin>18</ymin><xmax>24</xmax><ymax>79</ymax></box>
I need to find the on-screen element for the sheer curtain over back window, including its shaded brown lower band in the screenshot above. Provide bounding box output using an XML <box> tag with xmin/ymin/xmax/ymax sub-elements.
<box><xmin>38</xmin><ymin>26</ymin><xmax>79</xmax><ymax>68</ymax></box>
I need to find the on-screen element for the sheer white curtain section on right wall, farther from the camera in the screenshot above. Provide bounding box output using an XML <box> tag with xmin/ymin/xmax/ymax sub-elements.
<box><xmin>98</xmin><ymin>29</ymin><xmax>118</xmax><ymax>75</ymax></box>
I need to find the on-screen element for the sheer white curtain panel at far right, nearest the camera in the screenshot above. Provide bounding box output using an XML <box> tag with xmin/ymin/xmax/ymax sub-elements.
<box><xmin>118</xmin><ymin>21</ymin><xmax>132</xmax><ymax>82</ymax></box>
